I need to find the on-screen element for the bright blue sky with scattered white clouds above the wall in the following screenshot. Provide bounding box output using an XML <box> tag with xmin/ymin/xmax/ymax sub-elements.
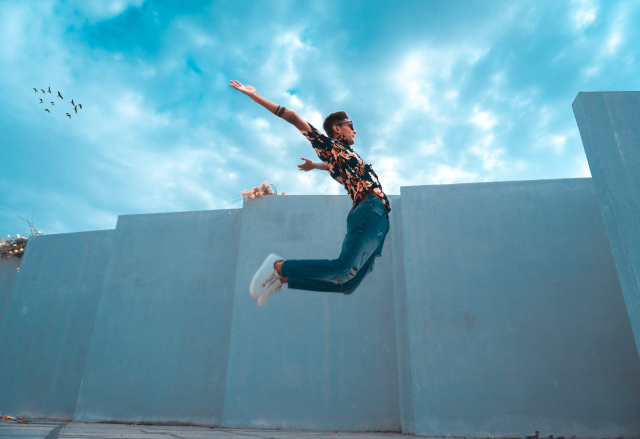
<box><xmin>0</xmin><ymin>0</ymin><xmax>640</xmax><ymax>236</ymax></box>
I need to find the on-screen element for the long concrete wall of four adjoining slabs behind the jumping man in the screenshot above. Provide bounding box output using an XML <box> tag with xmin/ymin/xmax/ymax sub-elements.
<box><xmin>0</xmin><ymin>179</ymin><xmax>640</xmax><ymax>438</ymax></box>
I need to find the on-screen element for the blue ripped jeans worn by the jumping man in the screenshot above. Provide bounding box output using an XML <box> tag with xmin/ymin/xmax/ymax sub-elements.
<box><xmin>281</xmin><ymin>194</ymin><xmax>389</xmax><ymax>295</ymax></box>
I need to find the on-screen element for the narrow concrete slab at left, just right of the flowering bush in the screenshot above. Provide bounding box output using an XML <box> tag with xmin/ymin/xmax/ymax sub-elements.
<box><xmin>0</xmin><ymin>230</ymin><xmax>113</xmax><ymax>419</ymax></box>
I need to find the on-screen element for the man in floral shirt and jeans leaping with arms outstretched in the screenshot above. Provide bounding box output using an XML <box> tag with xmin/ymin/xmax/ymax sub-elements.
<box><xmin>229</xmin><ymin>80</ymin><xmax>391</xmax><ymax>306</ymax></box>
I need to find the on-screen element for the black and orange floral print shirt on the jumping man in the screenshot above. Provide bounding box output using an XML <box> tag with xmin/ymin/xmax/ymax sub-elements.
<box><xmin>302</xmin><ymin>122</ymin><xmax>391</xmax><ymax>212</ymax></box>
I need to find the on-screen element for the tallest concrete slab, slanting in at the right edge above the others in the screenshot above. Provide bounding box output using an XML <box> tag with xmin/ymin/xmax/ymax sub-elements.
<box><xmin>573</xmin><ymin>92</ymin><xmax>640</xmax><ymax>358</ymax></box>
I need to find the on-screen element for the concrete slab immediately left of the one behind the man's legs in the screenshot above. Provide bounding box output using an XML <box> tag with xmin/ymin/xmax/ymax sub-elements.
<box><xmin>74</xmin><ymin>209</ymin><xmax>241</xmax><ymax>425</ymax></box>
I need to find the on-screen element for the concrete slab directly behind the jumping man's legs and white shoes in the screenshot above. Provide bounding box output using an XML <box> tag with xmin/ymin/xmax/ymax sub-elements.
<box><xmin>224</xmin><ymin>195</ymin><xmax>400</xmax><ymax>431</ymax></box>
